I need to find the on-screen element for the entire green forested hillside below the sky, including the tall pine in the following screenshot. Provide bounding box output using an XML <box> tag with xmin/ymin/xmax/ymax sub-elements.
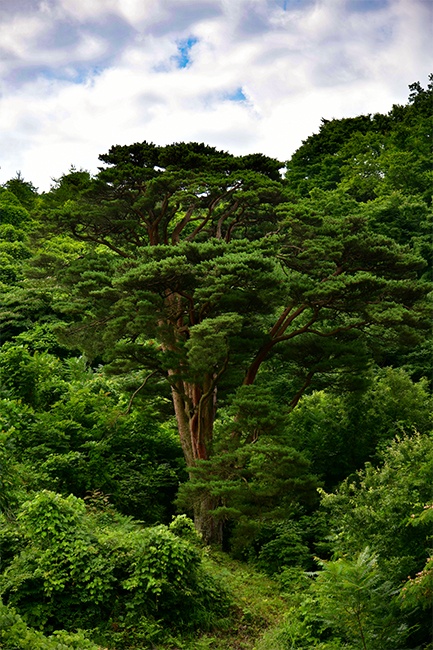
<box><xmin>0</xmin><ymin>76</ymin><xmax>433</xmax><ymax>650</ymax></box>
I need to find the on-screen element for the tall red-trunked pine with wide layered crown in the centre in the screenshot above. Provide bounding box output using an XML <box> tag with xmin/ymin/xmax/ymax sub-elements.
<box><xmin>33</xmin><ymin>142</ymin><xmax>426</xmax><ymax>540</ymax></box>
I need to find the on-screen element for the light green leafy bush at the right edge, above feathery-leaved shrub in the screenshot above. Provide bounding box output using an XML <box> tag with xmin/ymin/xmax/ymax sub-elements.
<box><xmin>323</xmin><ymin>433</ymin><xmax>433</xmax><ymax>645</ymax></box>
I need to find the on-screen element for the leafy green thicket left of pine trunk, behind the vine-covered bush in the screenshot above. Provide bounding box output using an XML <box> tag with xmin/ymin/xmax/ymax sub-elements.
<box><xmin>0</xmin><ymin>345</ymin><xmax>184</xmax><ymax>523</ymax></box>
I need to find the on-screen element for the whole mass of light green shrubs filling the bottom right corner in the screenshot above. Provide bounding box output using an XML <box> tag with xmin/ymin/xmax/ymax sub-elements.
<box><xmin>258</xmin><ymin>434</ymin><xmax>432</xmax><ymax>650</ymax></box>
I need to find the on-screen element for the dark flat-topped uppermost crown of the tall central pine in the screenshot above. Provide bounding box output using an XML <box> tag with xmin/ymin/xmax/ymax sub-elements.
<box><xmin>41</xmin><ymin>142</ymin><xmax>283</xmax><ymax>258</ymax></box>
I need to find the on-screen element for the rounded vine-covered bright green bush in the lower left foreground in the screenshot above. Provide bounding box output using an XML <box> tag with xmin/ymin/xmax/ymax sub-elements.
<box><xmin>1</xmin><ymin>490</ymin><xmax>228</xmax><ymax>630</ymax></box>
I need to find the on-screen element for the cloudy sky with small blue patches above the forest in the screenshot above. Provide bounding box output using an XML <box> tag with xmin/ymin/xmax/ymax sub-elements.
<box><xmin>0</xmin><ymin>0</ymin><xmax>433</xmax><ymax>191</ymax></box>
